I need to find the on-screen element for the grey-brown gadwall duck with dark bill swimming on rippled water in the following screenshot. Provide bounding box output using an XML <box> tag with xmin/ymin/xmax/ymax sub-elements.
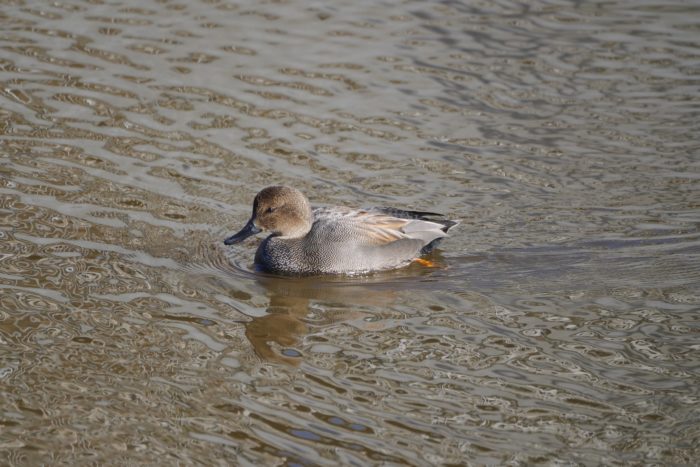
<box><xmin>224</xmin><ymin>186</ymin><xmax>457</xmax><ymax>274</ymax></box>
